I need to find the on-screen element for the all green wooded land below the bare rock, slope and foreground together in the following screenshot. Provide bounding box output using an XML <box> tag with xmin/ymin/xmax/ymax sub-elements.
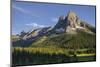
<box><xmin>12</xmin><ymin>32</ymin><xmax>96</xmax><ymax>66</ymax></box>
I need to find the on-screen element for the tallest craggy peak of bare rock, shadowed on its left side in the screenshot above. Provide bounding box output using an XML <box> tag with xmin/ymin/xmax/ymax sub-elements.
<box><xmin>53</xmin><ymin>11</ymin><xmax>93</xmax><ymax>34</ymax></box>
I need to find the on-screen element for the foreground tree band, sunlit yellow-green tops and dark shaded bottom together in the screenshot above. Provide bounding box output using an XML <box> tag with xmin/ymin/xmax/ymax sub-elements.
<box><xmin>12</xmin><ymin>47</ymin><xmax>95</xmax><ymax>66</ymax></box>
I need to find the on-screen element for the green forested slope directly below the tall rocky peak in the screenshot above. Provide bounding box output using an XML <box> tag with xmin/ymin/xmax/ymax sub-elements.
<box><xmin>30</xmin><ymin>31</ymin><xmax>96</xmax><ymax>49</ymax></box>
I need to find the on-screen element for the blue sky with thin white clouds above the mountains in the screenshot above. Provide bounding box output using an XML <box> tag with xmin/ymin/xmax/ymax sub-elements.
<box><xmin>11</xmin><ymin>1</ymin><xmax>96</xmax><ymax>34</ymax></box>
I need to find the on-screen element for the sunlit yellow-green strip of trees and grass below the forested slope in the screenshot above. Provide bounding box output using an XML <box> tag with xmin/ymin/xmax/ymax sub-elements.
<box><xmin>13</xmin><ymin>46</ymin><xmax>95</xmax><ymax>56</ymax></box>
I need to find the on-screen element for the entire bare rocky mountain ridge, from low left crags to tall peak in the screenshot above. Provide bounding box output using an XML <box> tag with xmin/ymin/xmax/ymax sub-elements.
<box><xmin>12</xmin><ymin>11</ymin><xmax>96</xmax><ymax>46</ymax></box>
